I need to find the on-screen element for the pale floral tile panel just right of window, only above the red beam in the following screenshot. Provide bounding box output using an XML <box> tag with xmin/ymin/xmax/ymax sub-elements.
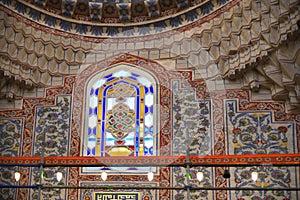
<box><xmin>172</xmin><ymin>80</ymin><xmax>212</xmax><ymax>155</ymax></box>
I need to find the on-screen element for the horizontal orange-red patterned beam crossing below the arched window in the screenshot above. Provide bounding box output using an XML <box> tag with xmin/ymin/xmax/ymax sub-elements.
<box><xmin>0</xmin><ymin>154</ymin><xmax>300</xmax><ymax>167</ymax></box>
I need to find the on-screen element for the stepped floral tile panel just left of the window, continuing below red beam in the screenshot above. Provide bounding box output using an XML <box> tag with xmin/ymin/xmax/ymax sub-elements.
<box><xmin>29</xmin><ymin>95</ymin><xmax>71</xmax><ymax>199</ymax></box>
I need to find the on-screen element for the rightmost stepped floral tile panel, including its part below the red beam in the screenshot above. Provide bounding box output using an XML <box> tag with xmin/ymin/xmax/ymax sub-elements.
<box><xmin>225</xmin><ymin>100</ymin><xmax>299</xmax><ymax>200</ymax></box>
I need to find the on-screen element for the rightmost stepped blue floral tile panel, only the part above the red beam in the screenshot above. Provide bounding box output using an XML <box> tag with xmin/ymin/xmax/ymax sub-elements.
<box><xmin>226</xmin><ymin>100</ymin><xmax>295</xmax><ymax>154</ymax></box>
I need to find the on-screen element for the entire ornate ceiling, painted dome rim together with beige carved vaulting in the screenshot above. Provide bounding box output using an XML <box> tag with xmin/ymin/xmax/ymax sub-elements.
<box><xmin>0</xmin><ymin>0</ymin><xmax>300</xmax><ymax>112</ymax></box>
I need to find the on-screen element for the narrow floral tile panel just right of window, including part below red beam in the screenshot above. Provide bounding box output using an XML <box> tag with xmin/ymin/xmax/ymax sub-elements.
<box><xmin>172</xmin><ymin>81</ymin><xmax>213</xmax><ymax>200</ymax></box>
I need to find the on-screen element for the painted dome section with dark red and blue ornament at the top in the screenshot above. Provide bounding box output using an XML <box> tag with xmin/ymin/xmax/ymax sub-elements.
<box><xmin>0</xmin><ymin>0</ymin><xmax>234</xmax><ymax>37</ymax></box>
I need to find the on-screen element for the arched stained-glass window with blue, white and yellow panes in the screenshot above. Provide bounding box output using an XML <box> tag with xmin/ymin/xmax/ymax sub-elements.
<box><xmin>82</xmin><ymin>64</ymin><xmax>158</xmax><ymax>171</ymax></box>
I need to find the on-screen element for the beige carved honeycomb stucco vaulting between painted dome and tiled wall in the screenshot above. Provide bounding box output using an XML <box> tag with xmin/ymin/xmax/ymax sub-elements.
<box><xmin>0</xmin><ymin>0</ymin><xmax>300</xmax><ymax>112</ymax></box>
